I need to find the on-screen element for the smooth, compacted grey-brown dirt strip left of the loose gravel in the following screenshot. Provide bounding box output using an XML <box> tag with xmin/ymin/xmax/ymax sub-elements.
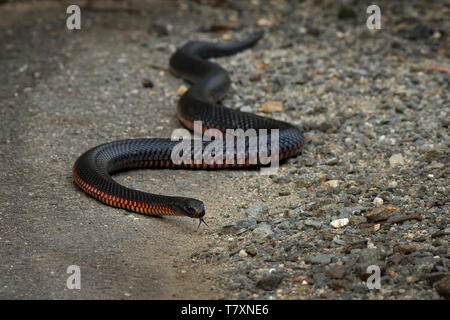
<box><xmin>0</xmin><ymin>1</ymin><xmax>229</xmax><ymax>299</ymax></box>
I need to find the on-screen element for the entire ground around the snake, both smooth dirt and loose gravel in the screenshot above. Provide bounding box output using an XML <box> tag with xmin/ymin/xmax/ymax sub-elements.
<box><xmin>0</xmin><ymin>0</ymin><xmax>450</xmax><ymax>299</ymax></box>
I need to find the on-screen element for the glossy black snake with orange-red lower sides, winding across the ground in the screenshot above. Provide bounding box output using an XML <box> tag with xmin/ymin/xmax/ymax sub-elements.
<box><xmin>72</xmin><ymin>31</ymin><xmax>304</xmax><ymax>226</ymax></box>
